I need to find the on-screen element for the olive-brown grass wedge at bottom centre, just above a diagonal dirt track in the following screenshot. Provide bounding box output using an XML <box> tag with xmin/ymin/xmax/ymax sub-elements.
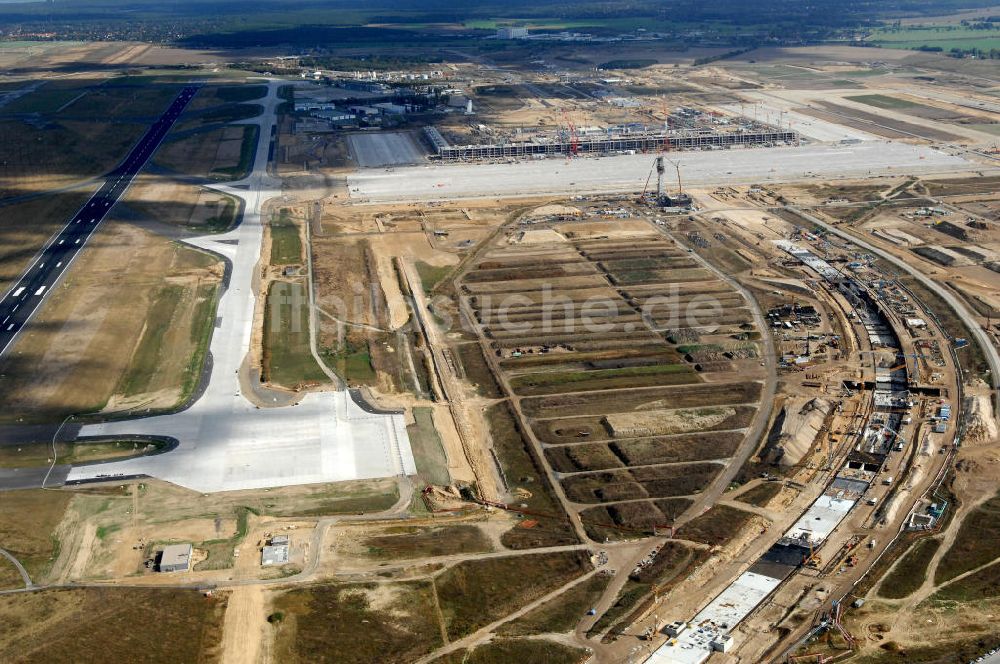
<box><xmin>434</xmin><ymin>551</ymin><xmax>591</xmax><ymax>639</ymax></box>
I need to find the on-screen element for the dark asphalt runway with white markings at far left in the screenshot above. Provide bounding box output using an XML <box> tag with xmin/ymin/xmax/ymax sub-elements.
<box><xmin>0</xmin><ymin>85</ymin><xmax>198</xmax><ymax>356</ymax></box>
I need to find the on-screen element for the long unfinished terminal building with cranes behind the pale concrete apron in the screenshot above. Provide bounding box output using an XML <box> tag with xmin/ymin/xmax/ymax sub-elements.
<box><xmin>424</xmin><ymin>127</ymin><xmax>799</xmax><ymax>161</ymax></box>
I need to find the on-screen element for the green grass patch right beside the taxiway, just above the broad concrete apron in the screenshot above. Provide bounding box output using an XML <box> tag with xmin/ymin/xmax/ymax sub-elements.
<box><xmin>263</xmin><ymin>281</ymin><xmax>328</xmax><ymax>388</ymax></box>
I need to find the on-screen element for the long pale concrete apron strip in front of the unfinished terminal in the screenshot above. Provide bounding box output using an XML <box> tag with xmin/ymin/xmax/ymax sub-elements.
<box><xmin>347</xmin><ymin>141</ymin><xmax>982</xmax><ymax>202</ymax></box>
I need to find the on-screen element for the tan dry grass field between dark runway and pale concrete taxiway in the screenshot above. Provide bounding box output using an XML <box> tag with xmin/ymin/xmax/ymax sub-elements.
<box><xmin>0</xmin><ymin>221</ymin><xmax>222</xmax><ymax>421</ymax></box>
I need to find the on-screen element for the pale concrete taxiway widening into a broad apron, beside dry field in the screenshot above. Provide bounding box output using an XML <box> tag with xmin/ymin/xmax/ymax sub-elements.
<box><xmin>66</xmin><ymin>82</ymin><xmax>416</xmax><ymax>492</ymax></box>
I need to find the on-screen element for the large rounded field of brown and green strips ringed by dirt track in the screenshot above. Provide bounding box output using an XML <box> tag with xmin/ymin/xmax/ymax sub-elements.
<box><xmin>456</xmin><ymin>215</ymin><xmax>762</xmax><ymax>541</ymax></box>
